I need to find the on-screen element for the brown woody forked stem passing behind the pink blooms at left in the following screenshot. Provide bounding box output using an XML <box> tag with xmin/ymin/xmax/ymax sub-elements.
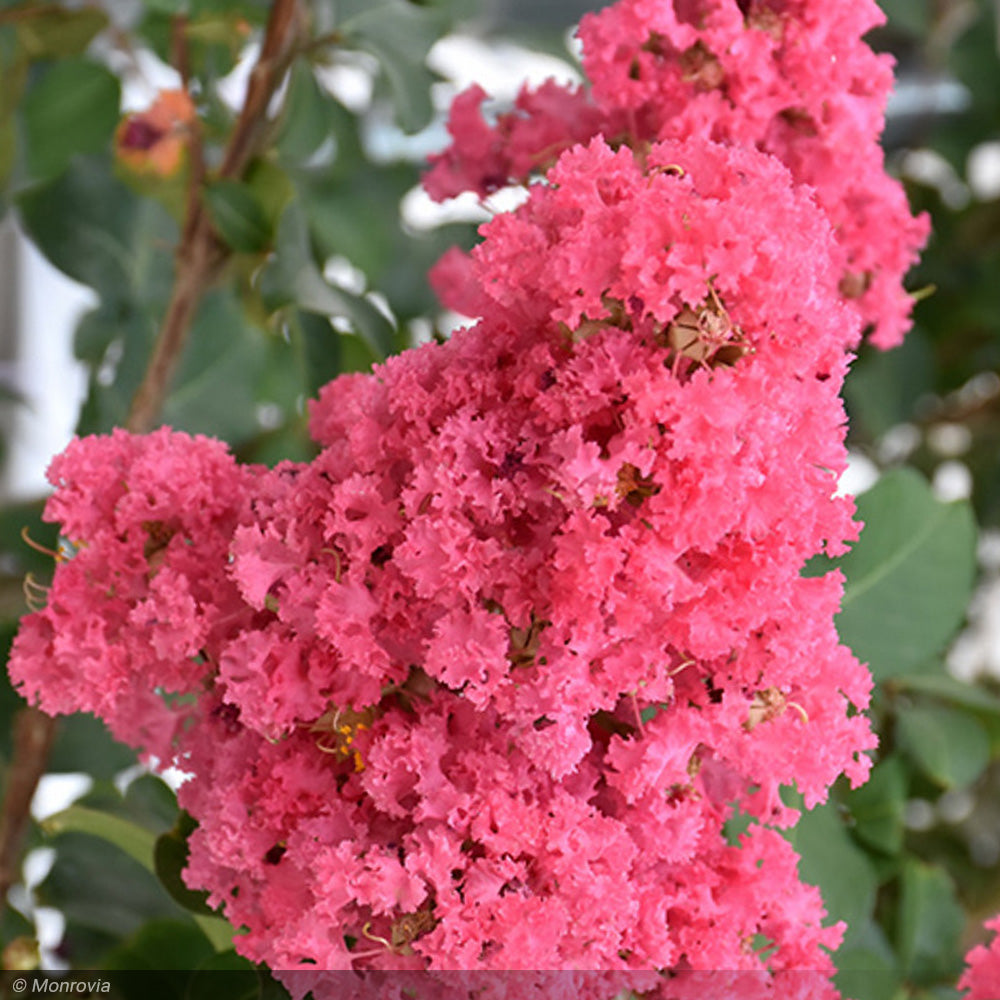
<box><xmin>0</xmin><ymin>0</ymin><xmax>304</xmax><ymax>907</ymax></box>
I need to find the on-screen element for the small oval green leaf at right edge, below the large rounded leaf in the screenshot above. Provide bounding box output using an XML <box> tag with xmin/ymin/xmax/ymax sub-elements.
<box><xmin>896</xmin><ymin>705</ymin><xmax>990</xmax><ymax>788</ymax></box>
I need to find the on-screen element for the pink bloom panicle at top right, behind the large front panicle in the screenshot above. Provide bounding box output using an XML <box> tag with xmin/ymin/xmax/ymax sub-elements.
<box><xmin>425</xmin><ymin>0</ymin><xmax>928</xmax><ymax>347</ymax></box>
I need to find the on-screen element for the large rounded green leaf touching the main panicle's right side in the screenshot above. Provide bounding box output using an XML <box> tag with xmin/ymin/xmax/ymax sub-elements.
<box><xmin>809</xmin><ymin>469</ymin><xmax>976</xmax><ymax>681</ymax></box>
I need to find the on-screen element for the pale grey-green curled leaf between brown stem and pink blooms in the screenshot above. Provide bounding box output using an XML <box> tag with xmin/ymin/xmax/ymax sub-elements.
<box><xmin>260</xmin><ymin>202</ymin><xmax>394</xmax><ymax>359</ymax></box>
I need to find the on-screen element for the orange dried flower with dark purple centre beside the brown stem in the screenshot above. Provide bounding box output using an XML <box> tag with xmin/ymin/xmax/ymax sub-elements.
<box><xmin>115</xmin><ymin>90</ymin><xmax>197</xmax><ymax>177</ymax></box>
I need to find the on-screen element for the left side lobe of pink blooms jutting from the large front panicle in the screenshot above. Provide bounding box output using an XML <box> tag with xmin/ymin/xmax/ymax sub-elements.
<box><xmin>11</xmin><ymin>430</ymin><xmax>253</xmax><ymax>761</ymax></box>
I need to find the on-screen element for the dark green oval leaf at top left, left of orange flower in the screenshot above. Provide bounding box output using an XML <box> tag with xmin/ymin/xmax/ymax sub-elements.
<box><xmin>22</xmin><ymin>57</ymin><xmax>119</xmax><ymax>180</ymax></box>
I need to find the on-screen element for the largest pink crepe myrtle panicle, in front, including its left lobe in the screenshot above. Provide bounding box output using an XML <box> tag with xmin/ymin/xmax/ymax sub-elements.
<box><xmin>11</xmin><ymin>127</ymin><xmax>874</xmax><ymax>998</ymax></box>
